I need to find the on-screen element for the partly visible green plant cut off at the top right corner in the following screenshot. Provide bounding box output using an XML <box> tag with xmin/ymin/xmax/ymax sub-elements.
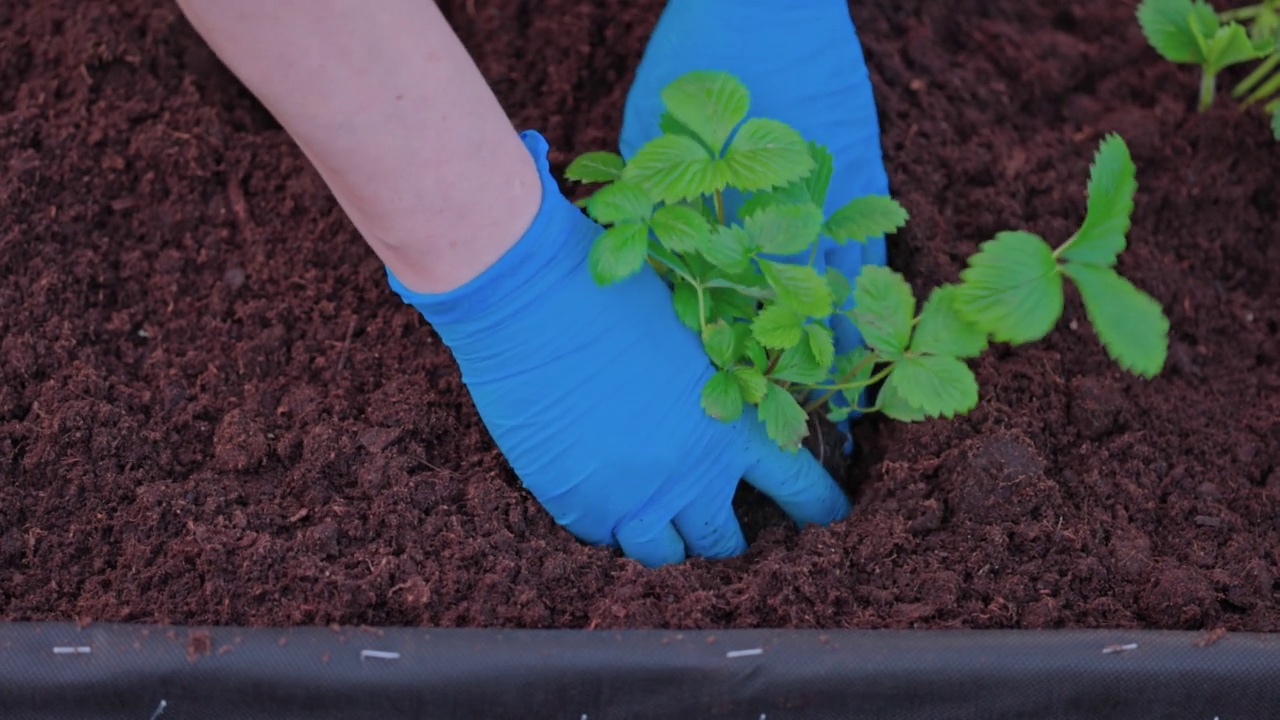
<box><xmin>1138</xmin><ymin>0</ymin><xmax>1280</xmax><ymax>140</ymax></box>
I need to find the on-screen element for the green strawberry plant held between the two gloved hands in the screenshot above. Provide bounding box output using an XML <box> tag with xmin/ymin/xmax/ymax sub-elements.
<box><xmin>566</xmin><ymin>72</ymin><xmax>1169</xmax><ymax>448</ymax></box>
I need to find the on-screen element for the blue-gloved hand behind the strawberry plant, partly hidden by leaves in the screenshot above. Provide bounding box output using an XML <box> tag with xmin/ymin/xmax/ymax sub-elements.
<box><xmin>620</xmin><ymin>0</ymin><xmax>888</xmax><ymax>440</ymax></box>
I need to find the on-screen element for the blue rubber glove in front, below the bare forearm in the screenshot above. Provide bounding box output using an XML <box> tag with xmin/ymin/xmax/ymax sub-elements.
<box><xmin>388</xmin><ymin>132</ymin><xmax>849</xmax><ymax>566</ymax></box>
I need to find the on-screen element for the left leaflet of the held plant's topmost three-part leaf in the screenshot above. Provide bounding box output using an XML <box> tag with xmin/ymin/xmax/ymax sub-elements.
<box><xmin>622</xmin><ymin>135</ymin><xmax>728</xmax><ymax>204</ymax></box>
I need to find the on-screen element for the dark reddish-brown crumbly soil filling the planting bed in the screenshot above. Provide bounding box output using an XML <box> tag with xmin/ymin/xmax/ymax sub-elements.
<box><xmin>0</xmin><ymin>0</ymin><xmax>1280</xmax><ymax>632</ymax></box>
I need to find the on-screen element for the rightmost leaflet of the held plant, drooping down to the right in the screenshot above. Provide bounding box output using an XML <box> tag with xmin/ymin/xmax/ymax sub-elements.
<box><xmin>1062</xmin><ymin>263</ymin><xmax>1169</xmax><ymax>379</ymax></box>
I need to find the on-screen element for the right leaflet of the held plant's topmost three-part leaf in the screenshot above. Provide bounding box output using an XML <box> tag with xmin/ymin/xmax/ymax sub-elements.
<box><xmin>721</xmin><ymin>118</ymin><xmax>814</xmax><ymax>192</ymax></box>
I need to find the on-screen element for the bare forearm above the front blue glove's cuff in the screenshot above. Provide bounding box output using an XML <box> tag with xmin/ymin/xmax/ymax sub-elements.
<box><xmin>178</xmin><ymin>0</ymin><xmax>540</xmax><ymax>292</ymax></box>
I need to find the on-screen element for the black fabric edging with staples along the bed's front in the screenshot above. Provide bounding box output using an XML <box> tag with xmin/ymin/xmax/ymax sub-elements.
<box><xmin>0</xmin><ymin>623</ymin><xmax>1280</xmax><ymax>720</ymax></box>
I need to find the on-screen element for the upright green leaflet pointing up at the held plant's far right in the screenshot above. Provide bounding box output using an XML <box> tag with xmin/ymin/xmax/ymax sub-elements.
<box><xmin>1061</xmin><ymin>135</ymin><xmax>1138</xmax><ymax>266</ymax></box>
